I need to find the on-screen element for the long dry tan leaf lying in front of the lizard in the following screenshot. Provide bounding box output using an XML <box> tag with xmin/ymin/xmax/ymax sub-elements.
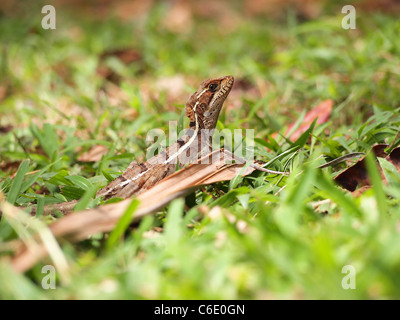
<box><xmin>12</xmin><ymin>149</ymin><xmax>254</xmax><ymax>272</ymax></box>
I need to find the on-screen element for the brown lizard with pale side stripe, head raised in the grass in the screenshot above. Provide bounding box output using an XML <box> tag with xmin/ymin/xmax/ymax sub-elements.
<box><xmin>36</xmin><ymin>76</ymin><xmax>234</xmax><ymax>214</ymax></box>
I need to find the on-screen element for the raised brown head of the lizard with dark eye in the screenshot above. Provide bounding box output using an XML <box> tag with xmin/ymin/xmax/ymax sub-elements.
<box><xmin>186</xmin><ymin>76</ymin><xmax>234</xmax><ymax>130</ymax></box>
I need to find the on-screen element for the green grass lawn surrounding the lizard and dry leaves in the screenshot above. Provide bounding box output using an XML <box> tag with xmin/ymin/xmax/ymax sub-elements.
<box><xmin>0</xmin><ymin>1</ymin><xmax>400</xmax><ymax>299</ymax></box>
